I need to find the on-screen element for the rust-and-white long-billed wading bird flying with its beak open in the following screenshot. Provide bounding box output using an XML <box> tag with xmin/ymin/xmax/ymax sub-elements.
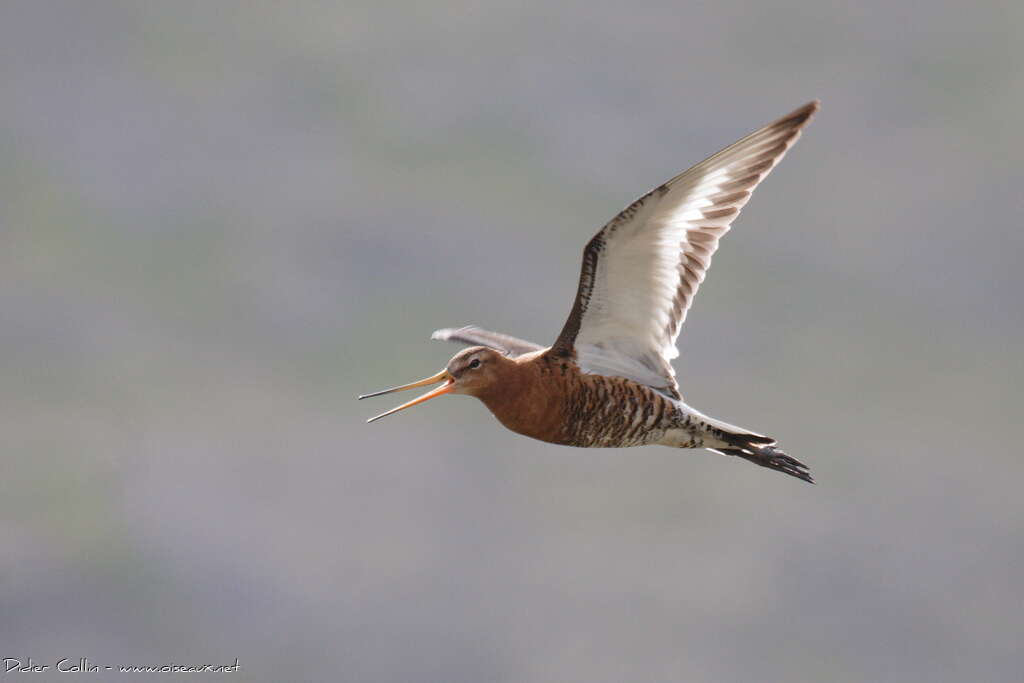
<box><xmin>358</xmin><ymin>100</ymin><xmax>820</xmax><ymax>483</ymax></box>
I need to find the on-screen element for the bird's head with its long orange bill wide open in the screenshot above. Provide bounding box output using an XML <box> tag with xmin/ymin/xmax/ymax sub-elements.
<box><xmin>359</xmin><ymin>346</ymin><xmax>515</xmax><ymax>422</ymax></box>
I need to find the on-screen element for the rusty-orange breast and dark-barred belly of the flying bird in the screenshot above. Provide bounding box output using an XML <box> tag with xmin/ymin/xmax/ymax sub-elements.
<box><xmin>480</xmin><ymin>353</ymin><xmax>677</xmax><ymax>447</ymax></box>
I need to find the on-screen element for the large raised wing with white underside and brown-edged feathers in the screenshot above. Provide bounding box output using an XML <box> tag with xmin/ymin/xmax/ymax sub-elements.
<box><xmin>552</xmin><ymin>100</ymin><xmax>818</xmax><ymax>397</ymax></box>
